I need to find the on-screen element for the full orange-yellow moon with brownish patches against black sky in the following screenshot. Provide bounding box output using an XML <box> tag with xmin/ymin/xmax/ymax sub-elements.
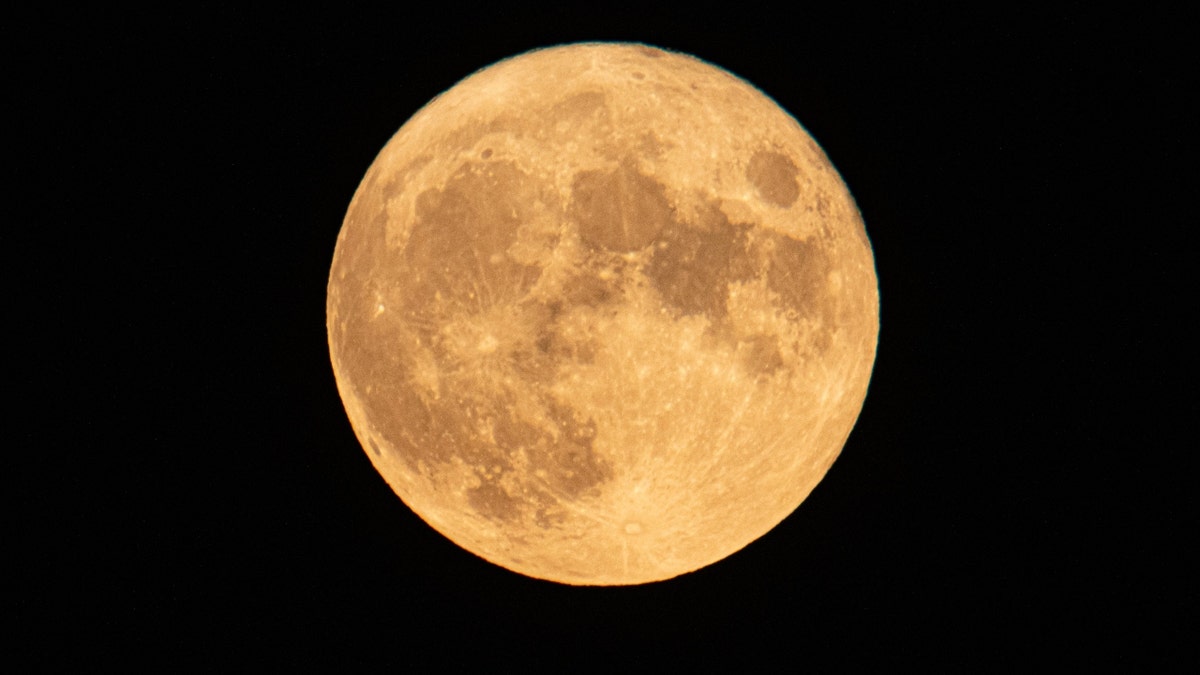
<box><xmin>326</xmin><ymin>43</ymin><xmax>878</xmax><ymax>585</ymax></box>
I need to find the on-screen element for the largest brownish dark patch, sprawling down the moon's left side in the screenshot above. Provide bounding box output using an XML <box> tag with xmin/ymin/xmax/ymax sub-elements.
<box><xmin>346</xmin><ymin>153</ymin><xmax>619</xmax><ymax>527</ymax></box>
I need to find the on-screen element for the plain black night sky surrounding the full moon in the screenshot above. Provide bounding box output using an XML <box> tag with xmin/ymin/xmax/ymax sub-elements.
<box><xmin>14</xmin><ymin>4</ymin><xmax>1200</xmax><ymax>670</ymax></box>
